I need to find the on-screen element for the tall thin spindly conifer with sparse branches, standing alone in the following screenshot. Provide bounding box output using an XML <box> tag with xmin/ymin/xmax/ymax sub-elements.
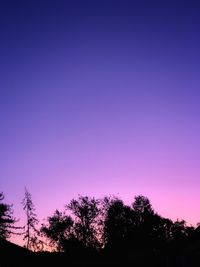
<box><xmin>22</xmin><ymin>188</ymin><xmax>41</xmax><ymax>250</ymax></box>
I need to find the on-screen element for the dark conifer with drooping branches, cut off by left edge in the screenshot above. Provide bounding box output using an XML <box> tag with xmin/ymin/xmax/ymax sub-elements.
<box><xmin>0</xmin><ymin>193</ymin><xmax>18</xmax><ymax>239</ymax></box>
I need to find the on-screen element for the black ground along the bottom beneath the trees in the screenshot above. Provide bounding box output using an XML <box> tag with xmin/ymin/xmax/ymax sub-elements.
<box><xmin>0</xmin><ymin>240</ymin><xmax>200</xmax><ymax>267</ymax></box>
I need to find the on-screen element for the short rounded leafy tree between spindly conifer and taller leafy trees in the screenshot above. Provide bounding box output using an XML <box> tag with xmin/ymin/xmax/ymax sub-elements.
<box><xmin>41</xmin><ymin>210</ymin><xmax>73</xmax><ymax>251</ymax></box>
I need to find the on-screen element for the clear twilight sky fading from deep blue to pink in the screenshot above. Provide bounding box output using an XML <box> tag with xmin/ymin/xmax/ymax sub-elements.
<box><xmin>0</xmin><ymin>0</ymin><xmax>200</xmax><ymax>246</ymax></box>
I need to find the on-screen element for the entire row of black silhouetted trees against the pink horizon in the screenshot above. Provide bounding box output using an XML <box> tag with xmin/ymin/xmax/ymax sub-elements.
<box><xmin>0</xmin><ymin>190</ymin><xmax>200</xmax><ymax>266</ymax></box>
